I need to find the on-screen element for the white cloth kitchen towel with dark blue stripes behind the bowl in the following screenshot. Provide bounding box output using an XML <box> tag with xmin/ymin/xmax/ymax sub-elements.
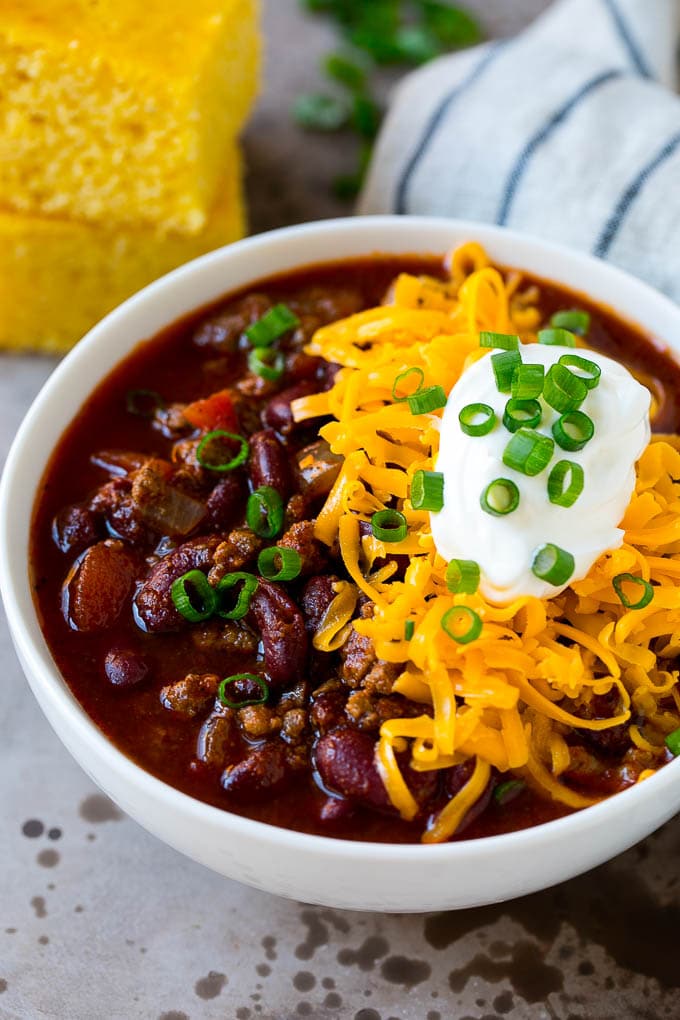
<box><xmin>359</xmin><ymin>0</ymin><xmax>680</xmax><ymax>302</ymax></box>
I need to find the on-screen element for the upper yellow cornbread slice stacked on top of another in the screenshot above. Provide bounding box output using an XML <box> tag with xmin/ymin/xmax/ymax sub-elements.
<box><xmin>0</xmin><ymin>0</ymin><xmax>260</xmax><ymax>234</ymax></box>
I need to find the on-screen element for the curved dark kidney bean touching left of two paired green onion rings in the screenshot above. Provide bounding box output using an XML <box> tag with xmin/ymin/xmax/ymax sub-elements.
<box><xmin>135</xmin><ymin>534</ymin><xmax>222</xmax><ymax>633</ymax></box>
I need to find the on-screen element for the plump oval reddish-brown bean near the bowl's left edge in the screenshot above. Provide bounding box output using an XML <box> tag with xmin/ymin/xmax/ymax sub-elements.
<box><xmin>62</xmin><ymin>539</ymin><xmax>135</xmax><ymax>631</ymax></box>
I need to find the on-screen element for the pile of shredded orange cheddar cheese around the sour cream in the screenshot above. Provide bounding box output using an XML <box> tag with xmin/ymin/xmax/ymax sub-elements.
<box><xmin>294</xmin><ymin>245</ymin><xmax>680</xmax><ymax>842</ymax></box>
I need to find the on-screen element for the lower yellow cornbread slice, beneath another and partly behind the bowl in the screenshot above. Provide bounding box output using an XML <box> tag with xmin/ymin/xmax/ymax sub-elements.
<box><xmin>0</xmin><ymin>156</ymin><xmax>245</xmax><ymax>352</ymax></box>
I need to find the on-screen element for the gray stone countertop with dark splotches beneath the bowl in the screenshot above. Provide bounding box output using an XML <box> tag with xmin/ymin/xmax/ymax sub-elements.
<box><xmin>0</xmin><ymin>0</ymin><xmax>680</xmax><ymax>1020</ymax></box>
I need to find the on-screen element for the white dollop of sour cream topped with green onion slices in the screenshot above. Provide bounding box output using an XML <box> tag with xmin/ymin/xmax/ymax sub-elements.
<box><xmin>430</xmin><ymin>344</ymin><xmax>650</xmax><ymax>605</ymax></box>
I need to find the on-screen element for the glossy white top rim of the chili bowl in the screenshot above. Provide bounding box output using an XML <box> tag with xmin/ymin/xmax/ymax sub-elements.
<box><xmin>0</xmin><ymin>215</ymin><xmax>680</xmax><ymax>864</ymax></box>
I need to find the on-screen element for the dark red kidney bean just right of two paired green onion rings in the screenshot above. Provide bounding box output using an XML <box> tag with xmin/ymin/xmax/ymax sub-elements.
<box><xmin>248</xmin><ymin>577</ymin><xmax>308</xmax><ymax>687</ymax></box>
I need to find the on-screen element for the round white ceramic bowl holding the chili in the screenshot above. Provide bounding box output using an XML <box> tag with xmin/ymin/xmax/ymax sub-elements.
<box><xmin>0</xmin><ymin>217</ymin><xmax>680</xmax><ymax>911</ymax></box>
